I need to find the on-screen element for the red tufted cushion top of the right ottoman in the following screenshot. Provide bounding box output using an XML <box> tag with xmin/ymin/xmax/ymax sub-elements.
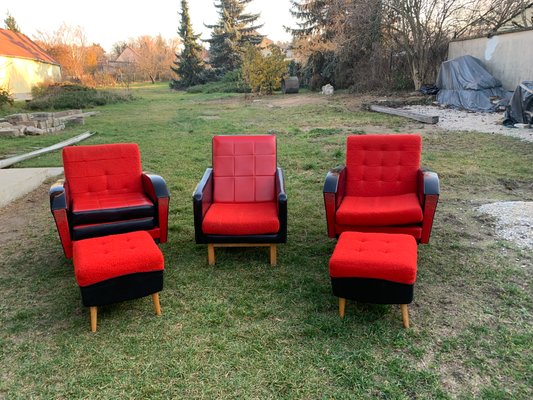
<box><xmin>329</xmin><ymin>232</ymin><xmax>417</xmax><ymax>285</ymax></box>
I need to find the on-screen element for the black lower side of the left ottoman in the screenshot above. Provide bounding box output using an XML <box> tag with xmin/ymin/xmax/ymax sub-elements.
<box><xmin>80</xmin><ymin>270</ymin><xmax>163</xmax><ymax>307</ymax></box>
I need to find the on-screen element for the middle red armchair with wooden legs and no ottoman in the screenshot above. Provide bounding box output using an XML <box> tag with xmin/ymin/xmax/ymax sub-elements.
<box><xmin>193</xmin><ymin>135</ymin><xmax>287</xmax><ymax>265</ymax></box>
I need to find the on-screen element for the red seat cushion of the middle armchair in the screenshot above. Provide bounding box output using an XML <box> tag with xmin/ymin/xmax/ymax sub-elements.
<box><xmin>202</xmin><ymin>202</ymin><xmax>279</xmax><ymax>235</ymax></box>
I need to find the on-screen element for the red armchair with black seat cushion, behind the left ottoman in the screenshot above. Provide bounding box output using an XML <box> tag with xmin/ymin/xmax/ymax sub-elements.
<box><xmin>49</xmin><ymin>143</ymin><xmax>170</xmax><ymax>258</ymax></box>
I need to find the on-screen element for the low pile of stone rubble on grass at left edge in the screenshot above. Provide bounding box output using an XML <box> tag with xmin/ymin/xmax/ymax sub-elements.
<box><xmin>0</xmin><ymin>110</ymin><xmax>97</xmax><ymax>136</ymax></box>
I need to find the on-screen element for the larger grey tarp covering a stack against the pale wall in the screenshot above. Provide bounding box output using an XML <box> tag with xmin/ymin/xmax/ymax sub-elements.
<box><xmin>436</xmin><ymin>56</ymin><xmax>505</xmax><ymax>112</ymax></box>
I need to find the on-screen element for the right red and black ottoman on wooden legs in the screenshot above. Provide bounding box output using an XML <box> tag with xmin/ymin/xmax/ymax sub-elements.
<box><xmin>329</xmin><ymin>232</ymin><xmax>417</xmax><ymax>328</ymax></box>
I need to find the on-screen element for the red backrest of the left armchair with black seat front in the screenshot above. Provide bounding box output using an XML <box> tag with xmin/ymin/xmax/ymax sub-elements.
<box><xmin>63</xmin><ymin>143</ymin><xmax>142</xmax><ymax>196</ymax></box>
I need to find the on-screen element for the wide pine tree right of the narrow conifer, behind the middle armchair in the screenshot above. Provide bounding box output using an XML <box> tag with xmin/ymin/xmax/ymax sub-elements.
<box><xmin>206</xmin><ymin>0</ymin><xmax>264</xmax><ymax>74</ymax></box>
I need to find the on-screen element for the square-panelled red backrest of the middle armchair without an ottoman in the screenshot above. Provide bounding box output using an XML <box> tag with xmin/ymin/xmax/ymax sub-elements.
<box><xmin>213</xmin><ymin>135</ymin><xmax>276</xmax><ymax>203</ymax></box>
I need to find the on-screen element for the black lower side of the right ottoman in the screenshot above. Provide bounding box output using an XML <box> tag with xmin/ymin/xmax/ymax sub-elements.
<box><xmin>331</xmin><ymin>277</ymin><xmax>415</xmax><ymax>304</ymax></box>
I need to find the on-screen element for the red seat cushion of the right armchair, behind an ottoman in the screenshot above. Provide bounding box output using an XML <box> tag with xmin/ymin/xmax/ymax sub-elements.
<box><xmin>335</xmin><ymin>193</ymin><xmax>423</xmax><ymax>226</ymax></box>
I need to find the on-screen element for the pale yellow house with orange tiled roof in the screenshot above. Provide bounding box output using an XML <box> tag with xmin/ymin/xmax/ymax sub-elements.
<box><xmin>0</xmin><ymin>29</ymin><xmax>61</xmax><ymax>100</ymax></box>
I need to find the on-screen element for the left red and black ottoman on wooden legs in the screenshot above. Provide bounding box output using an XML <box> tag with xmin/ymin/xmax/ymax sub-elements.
<box><xmin>73</xmin><ymin>231</ymin><xmax>164</xmax><ymax>332</ymax></box>
